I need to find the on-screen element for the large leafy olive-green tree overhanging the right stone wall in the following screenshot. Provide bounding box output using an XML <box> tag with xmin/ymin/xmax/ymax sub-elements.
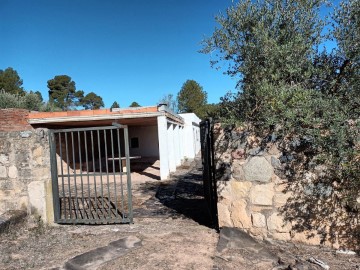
<box><xmin>203</xmin><ymin>0</ymin><xmax>360</xmax><ymax>247</ymax></box>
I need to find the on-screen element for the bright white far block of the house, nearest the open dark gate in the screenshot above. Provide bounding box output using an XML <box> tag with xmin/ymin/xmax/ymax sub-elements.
<box><xmin>179</xmin><ymin>113</ymin><xmax>201</xmax><ymax>159</ymax></box>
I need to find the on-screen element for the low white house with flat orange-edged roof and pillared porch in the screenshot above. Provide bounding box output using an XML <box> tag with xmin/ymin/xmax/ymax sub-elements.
<box><xmin>28</xmin><ymin>104</ymin><xmax>200</xmax><ymax>179</ymax></box>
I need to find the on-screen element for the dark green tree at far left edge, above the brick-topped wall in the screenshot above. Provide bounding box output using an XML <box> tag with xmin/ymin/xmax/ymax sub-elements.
<box><xmin>0</xmin><ymin>67</ymin><xmax>25</xmax><ymax>95</ymax></box>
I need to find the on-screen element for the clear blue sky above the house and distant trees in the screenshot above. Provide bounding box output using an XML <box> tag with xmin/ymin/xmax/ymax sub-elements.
<box><xmin>0</xmin><ymin>0</ymin><xmax>338</xmax><ymax>107</ymax></box>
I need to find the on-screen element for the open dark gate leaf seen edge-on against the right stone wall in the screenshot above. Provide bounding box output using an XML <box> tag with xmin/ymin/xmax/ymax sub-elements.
<box><xmin>200</xmin><ymin>119</ymin><xmax>219</xmax><ymax>230</ymax></box>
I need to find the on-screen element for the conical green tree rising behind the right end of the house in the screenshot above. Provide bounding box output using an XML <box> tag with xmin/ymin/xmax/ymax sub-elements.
<box><xmin>177</xmin><ymin>80</ymin><xmax>207</xmax><ymax>118</ymax></box>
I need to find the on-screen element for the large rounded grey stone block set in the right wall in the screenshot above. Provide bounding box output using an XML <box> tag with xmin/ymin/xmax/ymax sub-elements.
<box><xmin>243</xmin><ymin>156</ymin><xmax>274</xmax><ymax>183</ymax></box>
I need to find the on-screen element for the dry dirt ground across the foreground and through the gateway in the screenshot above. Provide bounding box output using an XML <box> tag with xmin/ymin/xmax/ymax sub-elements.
<box><xmin>0</xmin><ymin>157</ymin><xmax>360</xmax><ymax>270</ymax></box>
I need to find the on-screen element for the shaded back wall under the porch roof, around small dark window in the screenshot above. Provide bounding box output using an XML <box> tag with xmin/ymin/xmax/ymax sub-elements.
<box><xmin>129</xmin><ymin>125</ymin><xmax>159</xmax><ymax>157</ymax></box>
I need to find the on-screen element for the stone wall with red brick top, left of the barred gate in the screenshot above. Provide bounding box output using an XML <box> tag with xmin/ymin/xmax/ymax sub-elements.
<box><xmin>0</xmin><ymin>109</ymin><xmax>53</xmax><ymax>222</ymax></box>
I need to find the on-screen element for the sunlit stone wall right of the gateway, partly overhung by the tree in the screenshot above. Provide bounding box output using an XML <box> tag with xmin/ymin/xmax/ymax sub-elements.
<box><xmin>214</xmin><ymin>124</ymin><xmax>346</xmax><ymax>247</ymax></box>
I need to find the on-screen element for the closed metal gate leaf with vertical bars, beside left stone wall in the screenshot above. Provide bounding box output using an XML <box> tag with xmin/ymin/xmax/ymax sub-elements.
<box><xmin>49</xmin><ymin>124</ymin><xmax>133</xmax><ymax>224</ymax></box>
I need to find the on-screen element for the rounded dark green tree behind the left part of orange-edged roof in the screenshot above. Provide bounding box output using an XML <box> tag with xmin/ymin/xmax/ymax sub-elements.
<box><xmin>47</xmin><ymin>75</ymin><xmax>84</xmax><ymax>111</ymax></box>
